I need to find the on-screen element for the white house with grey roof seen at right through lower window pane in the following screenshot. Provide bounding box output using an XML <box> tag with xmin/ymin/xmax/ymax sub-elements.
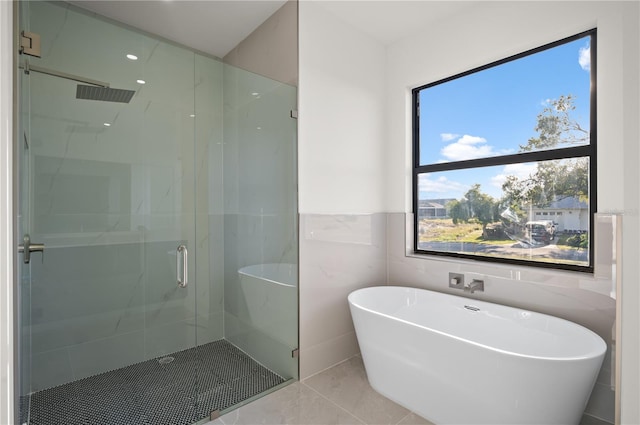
<box><xmin>532</xmin><ymin>197</ymin><xmax>589</xmax><ymax>233</ymax></box>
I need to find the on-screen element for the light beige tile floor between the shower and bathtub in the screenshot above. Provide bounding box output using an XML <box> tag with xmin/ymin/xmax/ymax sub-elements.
<box><xmin>206</xmin><ymin>356</ymin><xmax>433</xmax><ymax>425</ymax></box>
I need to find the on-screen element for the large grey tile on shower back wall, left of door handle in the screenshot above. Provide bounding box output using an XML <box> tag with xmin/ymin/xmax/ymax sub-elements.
<box><xmin>29</xmin><ymin>244</ymin><xmax>144</xmax><ymax>353</ymax></box>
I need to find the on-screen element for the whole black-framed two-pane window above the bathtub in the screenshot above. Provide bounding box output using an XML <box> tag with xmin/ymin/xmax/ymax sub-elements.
<box><xmin>413</xmin><ymin>29</ymin><xmax>596</xmax><ymax>272</ymax></box>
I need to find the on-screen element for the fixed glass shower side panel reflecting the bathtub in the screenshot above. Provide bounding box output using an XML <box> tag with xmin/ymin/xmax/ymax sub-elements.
<box><xmin>224</xmin><ymin>65</ymin><xmax>298</xmax><ymax>378</ymax></box>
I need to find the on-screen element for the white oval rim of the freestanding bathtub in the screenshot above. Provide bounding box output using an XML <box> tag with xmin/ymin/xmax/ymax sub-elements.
<box><xmin>347</xmin><ymin>285</ymin><xmax>609</xmax><ymax>362</ymax></box>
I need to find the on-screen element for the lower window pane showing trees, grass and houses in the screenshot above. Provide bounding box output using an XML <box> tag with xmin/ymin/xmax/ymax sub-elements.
<box><xmin>418</xmin><ymin>158</ymin><xmax>590</xmax><ymax>266</ymax></box>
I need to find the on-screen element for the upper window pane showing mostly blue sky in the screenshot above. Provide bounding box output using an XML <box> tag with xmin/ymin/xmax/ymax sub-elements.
<box><xmin>418</xmin><ymin>36</ymin><xmax>591</xmax><ymax>165</ymax></box>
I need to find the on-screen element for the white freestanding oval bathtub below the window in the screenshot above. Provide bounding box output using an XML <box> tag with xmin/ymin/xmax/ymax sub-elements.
<box><xmin>348</xmin><ymin>286</ymin><xmax>607</xmax><ymax>425</ymax></box>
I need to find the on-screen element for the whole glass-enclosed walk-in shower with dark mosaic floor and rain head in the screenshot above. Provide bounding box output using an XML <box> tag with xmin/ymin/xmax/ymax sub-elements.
<box><xmin>15</xmin><ymin>1</ymin><xmax>298</xmax><ymax>425</ymax></box>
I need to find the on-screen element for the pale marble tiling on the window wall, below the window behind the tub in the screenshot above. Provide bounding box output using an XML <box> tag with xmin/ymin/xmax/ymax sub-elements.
<box><xmin>388</xmin><ymin>213</ymin><xmax>615</xmax><ymax>343</ymax></box>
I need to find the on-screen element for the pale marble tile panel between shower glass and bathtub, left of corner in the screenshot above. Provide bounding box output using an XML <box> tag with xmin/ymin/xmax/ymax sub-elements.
<box><xmin>300</xmin><ymin>214</ymin><xmax>387</xmax><ymax>378</ymax></box>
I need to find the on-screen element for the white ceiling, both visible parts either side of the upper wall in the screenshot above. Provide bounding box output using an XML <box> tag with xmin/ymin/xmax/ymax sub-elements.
<box><xmin>70</xmin><ymin>0</ymin><xmax>477</xmax><ymax>58</ymax></box>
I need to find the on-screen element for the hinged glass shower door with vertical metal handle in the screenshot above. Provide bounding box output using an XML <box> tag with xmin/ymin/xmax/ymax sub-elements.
<box><xmin>17</xmin><ymin>2</ymin><xmax>197</xmax><ymax>424</ymax></box>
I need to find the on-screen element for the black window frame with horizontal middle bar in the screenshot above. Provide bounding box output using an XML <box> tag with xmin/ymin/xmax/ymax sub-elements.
<box><xmin>411</xmin><ymin>28</ymin><xmax>598</xmax><ymax>273</ymax></box>
